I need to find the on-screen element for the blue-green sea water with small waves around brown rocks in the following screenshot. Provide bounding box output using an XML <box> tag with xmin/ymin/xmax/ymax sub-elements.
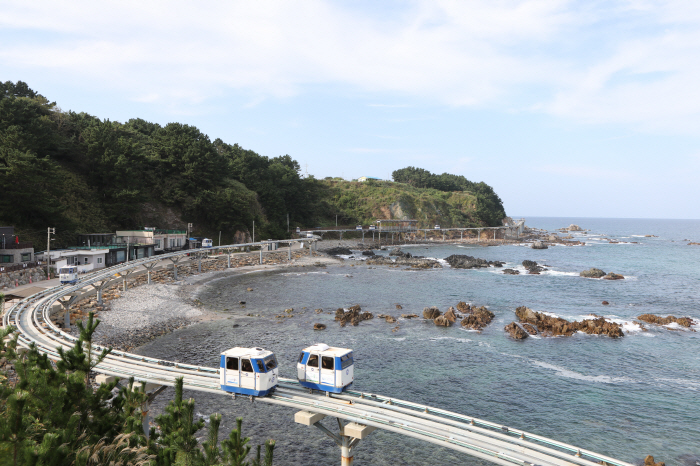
<box><xmin>133</xmin><ymin>218</ymin><xmax>700</xmax><ymax>466</ymax></box>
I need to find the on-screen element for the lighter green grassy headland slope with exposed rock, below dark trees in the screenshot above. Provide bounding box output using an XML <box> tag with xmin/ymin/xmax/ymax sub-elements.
<box><xmin>322</xmin><ymin>181</ymin><xmax>498</xmax><ymax>228</ymax></box>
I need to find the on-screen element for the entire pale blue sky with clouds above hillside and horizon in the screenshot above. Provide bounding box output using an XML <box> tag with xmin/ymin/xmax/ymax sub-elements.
<box><xmin>0</xmin><ymin>0</ymin><xmax>700</xmax><ymax>218</ymax></box>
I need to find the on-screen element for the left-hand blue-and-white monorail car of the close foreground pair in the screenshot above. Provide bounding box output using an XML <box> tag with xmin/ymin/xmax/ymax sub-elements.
<box><xmin>219</xmin><ymin>347</ymin><xmax>279</xmax><ymax>396</ymax></box>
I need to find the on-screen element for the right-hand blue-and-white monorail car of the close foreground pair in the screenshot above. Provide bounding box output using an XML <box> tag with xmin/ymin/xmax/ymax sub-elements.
<box><xmin>297</xmin><ymin>343</ymin><xmax>355</xmax><ymax>393</ymax></box>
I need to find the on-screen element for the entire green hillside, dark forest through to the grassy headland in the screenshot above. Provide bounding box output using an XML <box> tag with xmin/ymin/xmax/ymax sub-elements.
<box><xmin>0</xmin><ymin>81</ymin><xmax>505</xmax><ymax>248</ymax></box>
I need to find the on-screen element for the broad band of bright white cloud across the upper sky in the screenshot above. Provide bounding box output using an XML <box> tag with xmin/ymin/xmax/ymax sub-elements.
<box><xmin>0</xmin><ymin>0</ymin><xmax>700</xmax><ymax>132</ymax></box>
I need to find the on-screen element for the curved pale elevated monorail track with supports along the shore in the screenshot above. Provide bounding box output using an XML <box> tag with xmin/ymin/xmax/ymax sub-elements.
<box><xmin>3</xmin><ymin>239</ymin><xmax>632</xmax><ymax>466</ymax></box>
